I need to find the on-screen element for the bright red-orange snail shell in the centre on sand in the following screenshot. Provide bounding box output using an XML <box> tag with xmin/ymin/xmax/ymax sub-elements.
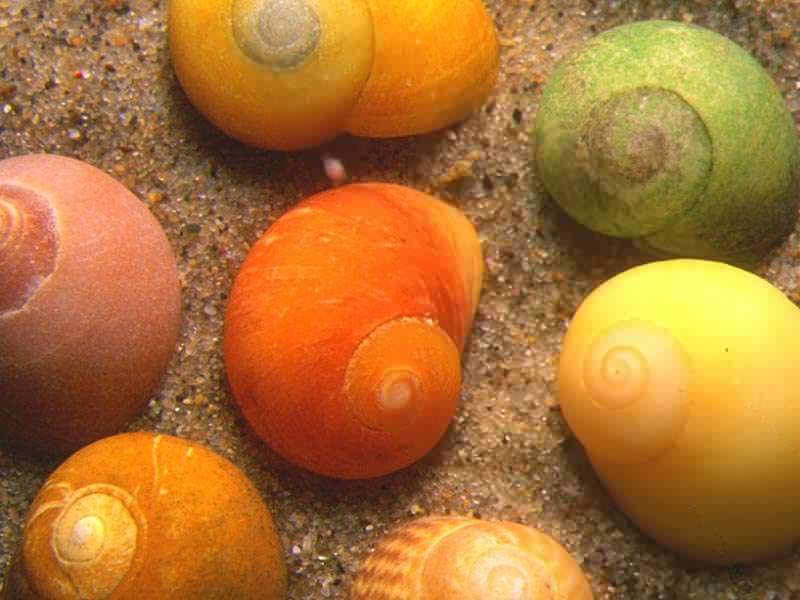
<box><xmin>224</xmin><ymin>183</ymin><xmax>482</xmax><ymax>478</ymax></box>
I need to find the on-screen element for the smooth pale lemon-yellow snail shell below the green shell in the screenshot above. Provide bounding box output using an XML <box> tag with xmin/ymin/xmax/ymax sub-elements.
<box><xmin>558</xmin><ymin>259</ymin><xmax>800</xmax><ymax>564</ymax></box>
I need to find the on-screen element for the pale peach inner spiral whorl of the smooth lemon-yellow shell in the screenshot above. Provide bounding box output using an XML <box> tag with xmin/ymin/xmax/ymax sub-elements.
<box><xmin>559</xmin><ymin>320</ymin><xmax>691</xmax><ymax>463</ymax></box>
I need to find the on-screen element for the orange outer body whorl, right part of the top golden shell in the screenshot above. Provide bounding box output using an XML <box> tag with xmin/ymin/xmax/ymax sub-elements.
<box><xmin>345</xmin><ymin>0</ymin><xmax>499</xmax><ymax>137</ymax></box>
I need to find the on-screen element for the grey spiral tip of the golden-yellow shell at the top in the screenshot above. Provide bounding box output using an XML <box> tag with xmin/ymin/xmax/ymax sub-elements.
<box><xmin>231</xmin><ymin>0</ymin><xmax>320</xmax><ymax>69</ymax></box>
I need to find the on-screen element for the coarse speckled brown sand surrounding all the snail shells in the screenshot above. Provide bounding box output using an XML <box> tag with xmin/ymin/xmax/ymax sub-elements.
<box><xmin>0</xmin><ymin>0</ymin><xmax>800</xmax><ymax>600</ymax></box>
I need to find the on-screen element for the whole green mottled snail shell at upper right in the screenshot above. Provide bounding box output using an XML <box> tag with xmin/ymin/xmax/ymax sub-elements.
<box><xmin>534</xmin><ymin>21</ymin><xmax>800</xmax><ymax>261</ymax></box>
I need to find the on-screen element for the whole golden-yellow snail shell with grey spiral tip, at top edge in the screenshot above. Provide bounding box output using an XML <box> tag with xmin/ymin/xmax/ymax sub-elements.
<box><xmin>169</xmin><ymin>0</ymin><xmax>499</xmax><ymax>150</ymax></box>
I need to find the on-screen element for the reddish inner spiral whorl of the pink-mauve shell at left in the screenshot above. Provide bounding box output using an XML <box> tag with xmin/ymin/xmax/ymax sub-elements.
<box><xmin>0</xmin><ymin>188</ymin><xmax>58</xmax><ymax>315</ymax></box>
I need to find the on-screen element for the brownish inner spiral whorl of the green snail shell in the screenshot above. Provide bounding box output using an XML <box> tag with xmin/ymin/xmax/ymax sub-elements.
<box><xmin>576</xmin><ymin>87</ymin><xmax>713</xmax><ymax>237</ymax></box>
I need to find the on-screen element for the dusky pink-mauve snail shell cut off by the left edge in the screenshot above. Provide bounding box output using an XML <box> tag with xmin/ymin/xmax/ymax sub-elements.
<box><xmin>0</xmin><ymin>154</ymin><xmax>181</xmax><ymax>454</ymax></box>
